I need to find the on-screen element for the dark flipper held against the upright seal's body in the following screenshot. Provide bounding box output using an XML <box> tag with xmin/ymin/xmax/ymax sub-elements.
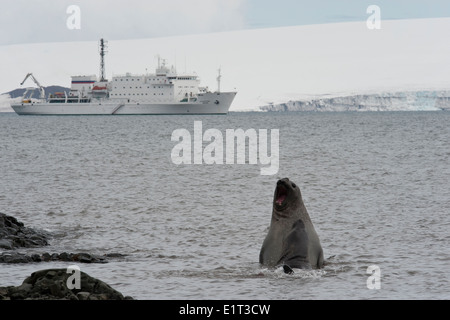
<box><xmin>278</xmin><ymin>219</ymin><xmax>311</xmax><ymax>274</ymax></box>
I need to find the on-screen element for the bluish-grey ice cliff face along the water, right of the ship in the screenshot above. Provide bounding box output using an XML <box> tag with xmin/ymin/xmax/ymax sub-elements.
<box><xmin>260</xmin><ymin>90</ymin><xmax>450</xmax><ymax>112</ymax></box>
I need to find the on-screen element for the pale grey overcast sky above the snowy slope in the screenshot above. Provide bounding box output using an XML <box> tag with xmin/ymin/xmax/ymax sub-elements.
<box><xmin>0</xmin><ymin>0</ymin><xmax>450</xmax><ymax>45</ymax></box>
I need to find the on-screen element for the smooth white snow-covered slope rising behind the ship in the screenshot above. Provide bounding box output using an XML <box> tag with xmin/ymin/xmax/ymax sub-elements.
<box><xmin>0</xmin><ymin>18</ymin><xmax>450</xmax><ymax>111</ymax></box>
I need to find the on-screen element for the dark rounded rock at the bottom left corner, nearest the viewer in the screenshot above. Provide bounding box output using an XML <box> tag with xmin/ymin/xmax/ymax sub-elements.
<box><xmin>0</xmin><ymin>269</ymin><xmax>133</xmax><ymax>300</ymax></box>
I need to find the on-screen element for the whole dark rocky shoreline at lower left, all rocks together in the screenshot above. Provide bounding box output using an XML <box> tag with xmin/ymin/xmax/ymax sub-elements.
<box><xmin>0</xmin><ymin>212</ymin><xmax>133</xmax><ymax>300</ymax></box>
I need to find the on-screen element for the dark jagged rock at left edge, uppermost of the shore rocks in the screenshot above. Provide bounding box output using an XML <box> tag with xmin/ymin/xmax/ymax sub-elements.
<box><xmin>0</xmin><ymin>212</ymin><xmax>50</xmax><ymax>250</ymax></box>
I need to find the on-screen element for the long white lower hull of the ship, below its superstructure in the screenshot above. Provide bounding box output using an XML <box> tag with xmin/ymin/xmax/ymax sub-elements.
<box><xmin>11</xmin><ymin>92</ymin><xmax>236</xmax><ymax>115</ymax></box>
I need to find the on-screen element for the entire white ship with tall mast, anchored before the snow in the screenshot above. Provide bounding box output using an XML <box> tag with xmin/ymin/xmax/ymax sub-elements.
<box><xmin>11</xmin><ymin>39</ymin><xmax>236</xmax><ymax>115</ymax></box>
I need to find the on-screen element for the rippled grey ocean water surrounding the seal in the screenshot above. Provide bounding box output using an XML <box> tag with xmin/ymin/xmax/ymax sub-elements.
<box><xmin>0</xmin><ymin>111</ymin><xmax>450</xmax><ymax>300</ymax></box>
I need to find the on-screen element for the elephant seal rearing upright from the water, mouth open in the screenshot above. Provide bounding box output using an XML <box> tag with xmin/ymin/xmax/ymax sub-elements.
<box><xmin>259</xmin><ymin>178</ymin><xmax>324</xmax><ymax>273</ymax></box>
